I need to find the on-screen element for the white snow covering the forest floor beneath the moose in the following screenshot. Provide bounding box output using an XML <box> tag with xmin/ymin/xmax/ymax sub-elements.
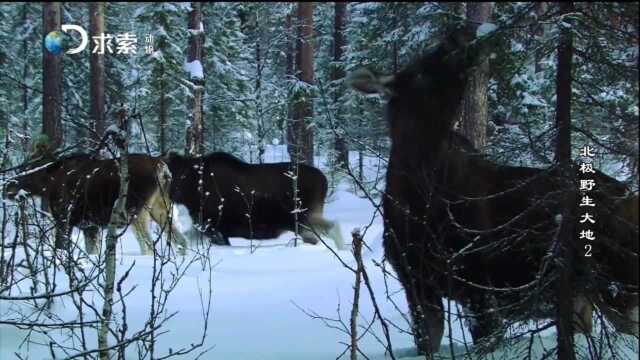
<box><xmin>0</xmin><ymin>146</ymin><xmax>638</xmax><ymax>360</ymax></box>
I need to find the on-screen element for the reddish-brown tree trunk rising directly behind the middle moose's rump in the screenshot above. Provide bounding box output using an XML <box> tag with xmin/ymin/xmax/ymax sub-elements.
<box><xmin>288</xmin><ymin>2</ymin><xmax>313</xmax><ymax>165</ymax></box>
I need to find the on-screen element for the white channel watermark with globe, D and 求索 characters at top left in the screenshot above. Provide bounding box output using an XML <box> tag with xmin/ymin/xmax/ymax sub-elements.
<box><xmin>44</xmin><ymin>24</ymin><xmax>153</xmax><ymax>55</ymax></box>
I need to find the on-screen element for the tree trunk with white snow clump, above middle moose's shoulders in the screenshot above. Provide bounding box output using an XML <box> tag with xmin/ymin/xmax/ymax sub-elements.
<box><xmin>187</xmin><ymin>2</ymin><xmax>204</xmax><ymax>156</ymax></box>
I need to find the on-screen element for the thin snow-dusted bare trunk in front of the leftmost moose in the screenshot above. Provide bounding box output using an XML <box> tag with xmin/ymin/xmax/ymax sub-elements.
<box><xmin>98</xmin><ymin>109</ymin><xmax>129</xmax><ymax>360</ymax></box>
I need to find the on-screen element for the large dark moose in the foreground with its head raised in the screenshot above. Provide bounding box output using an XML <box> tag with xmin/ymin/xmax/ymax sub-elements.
<box><xmin>348</xmin><ymin>27</ymin><xmax>638</xmax><ymax>356</ymax></box>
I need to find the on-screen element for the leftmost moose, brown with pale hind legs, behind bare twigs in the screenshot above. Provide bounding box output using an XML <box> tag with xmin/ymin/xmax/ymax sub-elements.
<box><xmin>4</xmin><ymin>153</ymin><xmax>186</xmax><ymax>254</ymax></box>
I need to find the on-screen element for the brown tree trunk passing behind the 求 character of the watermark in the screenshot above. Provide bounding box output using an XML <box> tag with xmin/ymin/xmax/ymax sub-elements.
<box><xmin>89</xmin><ymin>2</ymin><xmax>105</xmax><ymax>146</ymax></box>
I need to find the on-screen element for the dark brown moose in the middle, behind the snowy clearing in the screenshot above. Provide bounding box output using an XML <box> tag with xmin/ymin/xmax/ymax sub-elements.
<box><xmin>164</xmin><ymin>152</ymin><xmax>343</xmax><ymax>249</ymax></box>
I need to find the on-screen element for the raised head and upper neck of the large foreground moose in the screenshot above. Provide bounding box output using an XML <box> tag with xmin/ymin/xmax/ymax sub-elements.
<box><xmin>347</xmin><ymin>26</ymin><xmax>487</xmax><ymax>152</ymax></box>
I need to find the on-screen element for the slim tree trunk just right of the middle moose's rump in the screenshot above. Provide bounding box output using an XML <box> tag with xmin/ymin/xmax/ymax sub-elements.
<box><xmin>331</xmin><ymin>2</ymin><xmax>349</xmax><ymax>169</ymax></box>
